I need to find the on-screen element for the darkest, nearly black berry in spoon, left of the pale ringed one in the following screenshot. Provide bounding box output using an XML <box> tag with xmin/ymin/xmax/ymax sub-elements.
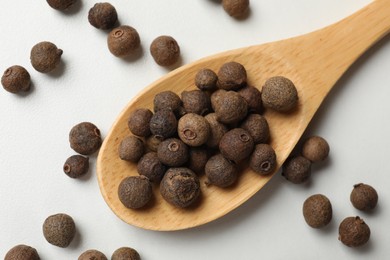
<box><xmin>149</xmin><ymin>109</ymin><xmax>177</xmax><ymax>139</ymax></box>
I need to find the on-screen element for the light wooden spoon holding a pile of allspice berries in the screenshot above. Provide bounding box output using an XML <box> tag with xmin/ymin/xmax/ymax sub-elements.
<box><xmin>97</xmin><ymin>0</ymin><xmax>390</xmax><ymax>231</ymax></box>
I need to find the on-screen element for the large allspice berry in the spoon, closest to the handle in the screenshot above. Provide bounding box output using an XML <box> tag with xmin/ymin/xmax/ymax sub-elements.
<box><xmin>261</xmin><ymin>76</ymin><xmax>298</xmax><ymax>112</ymax></box>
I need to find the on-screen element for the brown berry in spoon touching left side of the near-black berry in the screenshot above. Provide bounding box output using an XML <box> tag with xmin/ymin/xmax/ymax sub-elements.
<box><xmin>127</xmin><ymin>108</ymin><xmax>153</xmax><ymax>137</ymax></box>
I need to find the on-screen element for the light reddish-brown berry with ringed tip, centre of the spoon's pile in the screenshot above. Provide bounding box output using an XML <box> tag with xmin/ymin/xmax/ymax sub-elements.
<box><xmin>177</xmin><ymin>113</ymin><xmax>210</xmax><ymax>146</ymax></box>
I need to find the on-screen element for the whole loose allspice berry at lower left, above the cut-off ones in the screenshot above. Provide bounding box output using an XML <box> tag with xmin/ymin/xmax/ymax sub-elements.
<box><xmin>42</xmin><ymin>213</ymin><xmax>76</xmax><ymax>248</ymax></box>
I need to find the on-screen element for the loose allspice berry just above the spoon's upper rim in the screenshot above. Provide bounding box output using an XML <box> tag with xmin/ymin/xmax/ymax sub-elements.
<box><xmin>150</xmin><ymin>35</ymin><xmax>180</xmax><ymax>66</ymax></box>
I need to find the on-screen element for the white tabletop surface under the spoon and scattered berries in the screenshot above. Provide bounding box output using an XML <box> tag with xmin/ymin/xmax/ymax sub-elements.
<box><xmin>0</xmin><ymin>0</ymin><xmax>390</xmax><ymax>260</ymax></box>
